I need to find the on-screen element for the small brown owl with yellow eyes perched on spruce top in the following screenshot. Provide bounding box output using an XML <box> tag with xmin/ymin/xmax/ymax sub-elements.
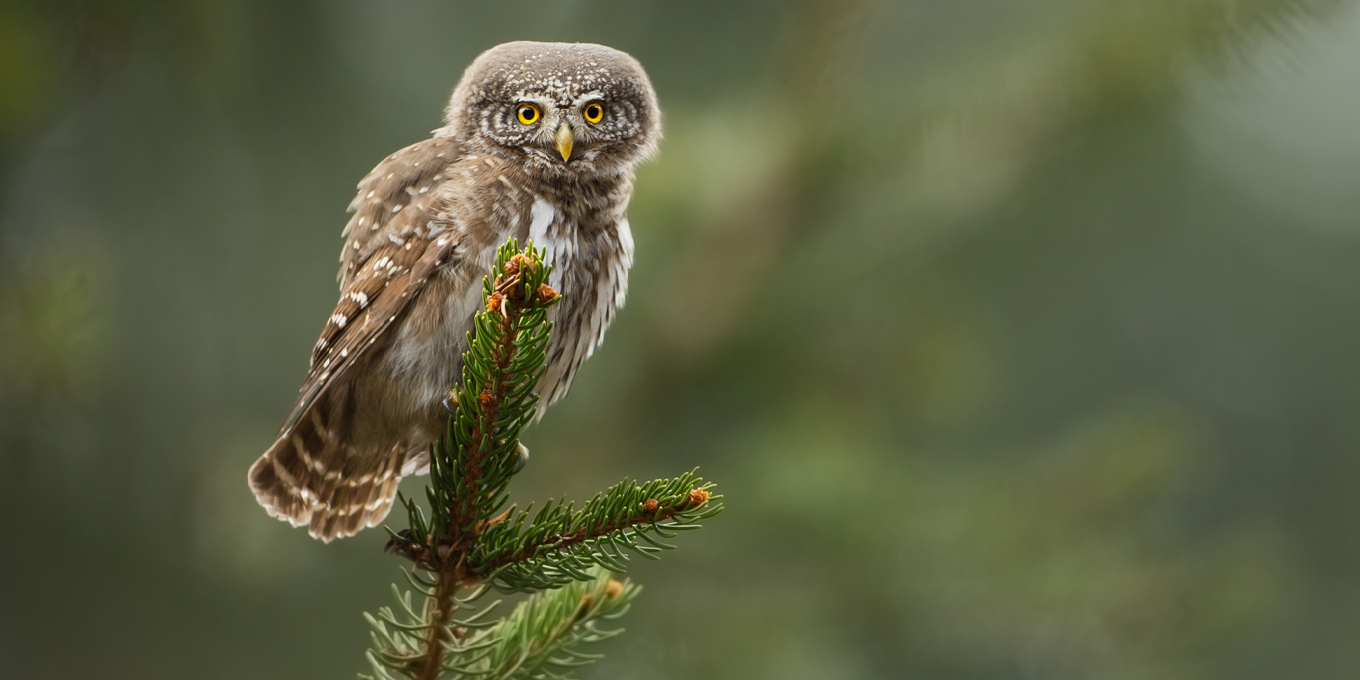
<box><xmin>249</xmin><ymin>42</ymin><xmax>661</xmax><ymax>541</ymax></box>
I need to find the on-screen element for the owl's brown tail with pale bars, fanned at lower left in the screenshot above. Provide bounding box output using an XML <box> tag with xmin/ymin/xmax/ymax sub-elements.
<box><xmin>250</xmin><ymin>408</ymin><xmax>405</xmax><ymax>543</ymax></box>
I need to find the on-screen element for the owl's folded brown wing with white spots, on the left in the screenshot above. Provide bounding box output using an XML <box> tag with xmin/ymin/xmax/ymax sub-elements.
<box><xmin>279</xmin><ymin>137</ymin><xmax>460</xmax><ymax>437</ymax></box>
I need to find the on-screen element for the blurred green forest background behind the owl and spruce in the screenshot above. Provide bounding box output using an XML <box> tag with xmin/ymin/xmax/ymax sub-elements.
<box><xmin>0</xmin><ymin>0</ymin><xmax>1360</xmax><ymax>680</ymax></box>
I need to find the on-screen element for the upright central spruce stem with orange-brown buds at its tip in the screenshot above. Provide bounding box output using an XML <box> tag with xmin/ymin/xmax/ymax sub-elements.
<box><xmin>371</xmin><ymin>239</ymin><xmax>560</xmax><ymax>680</ymax></box>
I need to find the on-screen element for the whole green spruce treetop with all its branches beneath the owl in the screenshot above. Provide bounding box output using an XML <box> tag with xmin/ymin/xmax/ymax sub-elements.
<box><xmin>362</xmin><ymin>239</ymin><xmax>722</xmax><ymax>680</ymax></box>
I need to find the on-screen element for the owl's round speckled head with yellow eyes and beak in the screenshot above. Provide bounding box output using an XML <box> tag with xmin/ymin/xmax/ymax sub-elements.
<box><xmin>445</xmin><ymin>42</ymin><xmax>661</xmax><ymax>177</ymax></box>
